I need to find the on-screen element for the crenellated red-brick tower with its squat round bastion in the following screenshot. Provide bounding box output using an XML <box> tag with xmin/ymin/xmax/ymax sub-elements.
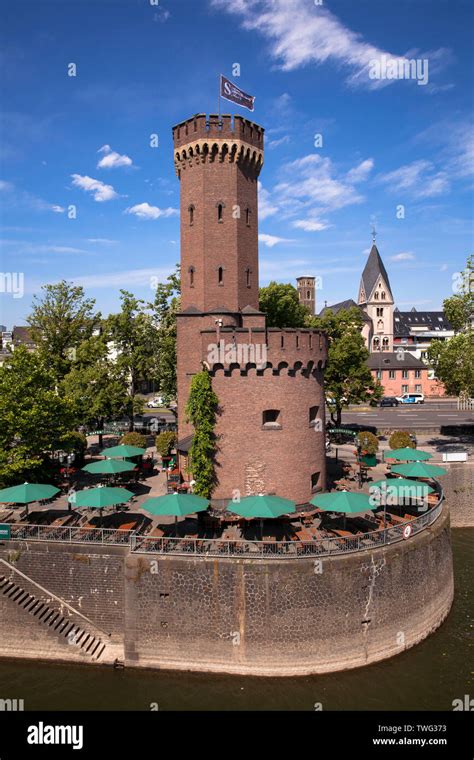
<box><xmin>173</xmin><ymin>114</ymin><xmax>327</xmax><ymax>506</ymax></box>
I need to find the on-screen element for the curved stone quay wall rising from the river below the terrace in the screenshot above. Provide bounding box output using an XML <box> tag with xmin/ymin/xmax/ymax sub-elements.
<box><xmin>0</xmin><ymin>505</ymin><xmax>453</xmax><ymax>676</ymax></box>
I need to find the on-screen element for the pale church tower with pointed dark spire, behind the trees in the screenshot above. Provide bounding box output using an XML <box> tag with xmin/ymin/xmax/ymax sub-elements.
<box><xmin>358</xmin><ymin>240</ymin><xmax>394</xmax><ymax>353</ymax></box>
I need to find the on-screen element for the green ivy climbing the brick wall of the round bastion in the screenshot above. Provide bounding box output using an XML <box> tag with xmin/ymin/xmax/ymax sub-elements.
<box><xmin>186</xmin><ymin>370</ymin><xmax>219</xmax><ymax>499</ymax></box>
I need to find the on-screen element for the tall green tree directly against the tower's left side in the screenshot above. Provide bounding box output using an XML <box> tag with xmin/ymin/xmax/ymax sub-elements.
<box><xmin>150</xmin><ymin>264</ymin><xmax>181</xmax><ymax>404</ymax></box>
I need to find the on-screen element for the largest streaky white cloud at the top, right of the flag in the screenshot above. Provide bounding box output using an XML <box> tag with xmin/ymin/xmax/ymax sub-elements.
<box><xmin>211</xmin><ymin>0</ymin><xmax>449</xmax><ymax>89</ymax></box>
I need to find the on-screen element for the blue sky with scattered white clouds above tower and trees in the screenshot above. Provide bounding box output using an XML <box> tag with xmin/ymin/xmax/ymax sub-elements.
<box><xmin>0</xmin><ymin>0</ymin><xmax>474</xmax><ymax>327</ymax></box>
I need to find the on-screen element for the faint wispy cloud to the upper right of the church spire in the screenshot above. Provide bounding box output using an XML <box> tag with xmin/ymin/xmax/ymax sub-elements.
<box><xmin>377</xmin><ymin>160</ymin><xmax>449</xmax><ymax>198</ymax></box>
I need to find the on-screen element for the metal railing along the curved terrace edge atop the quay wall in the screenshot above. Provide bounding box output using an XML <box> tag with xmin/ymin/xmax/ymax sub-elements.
<box><xmin>6</xmin><ymin>492</ymin><xmax>444</xmax><ymax>559</ymax></box>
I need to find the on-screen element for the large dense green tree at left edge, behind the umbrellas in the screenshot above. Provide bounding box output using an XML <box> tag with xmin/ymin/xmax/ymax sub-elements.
<box><xmin>0</xmin><ymin>346</ymin><xmax>75</xmax><ymax>485</ymax></box>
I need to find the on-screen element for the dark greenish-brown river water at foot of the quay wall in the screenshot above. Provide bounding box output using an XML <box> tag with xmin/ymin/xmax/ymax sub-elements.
<box><xmin>0</xmin><ymin>528</ymin><xmax>474</xmax><ymax>710</ymax></box>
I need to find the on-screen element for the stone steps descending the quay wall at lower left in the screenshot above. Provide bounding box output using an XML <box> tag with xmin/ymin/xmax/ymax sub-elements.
<box><xmin>0</xmin><ymin>575</ymin><xmax>106</xmax><ymax>661</ymax></box>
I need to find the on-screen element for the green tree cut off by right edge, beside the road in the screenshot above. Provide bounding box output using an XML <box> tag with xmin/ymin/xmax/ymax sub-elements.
<box><xmin>428</xmin><ymin>258</ymin><xmax>474</xmax><ymax>398</ymax></box>
